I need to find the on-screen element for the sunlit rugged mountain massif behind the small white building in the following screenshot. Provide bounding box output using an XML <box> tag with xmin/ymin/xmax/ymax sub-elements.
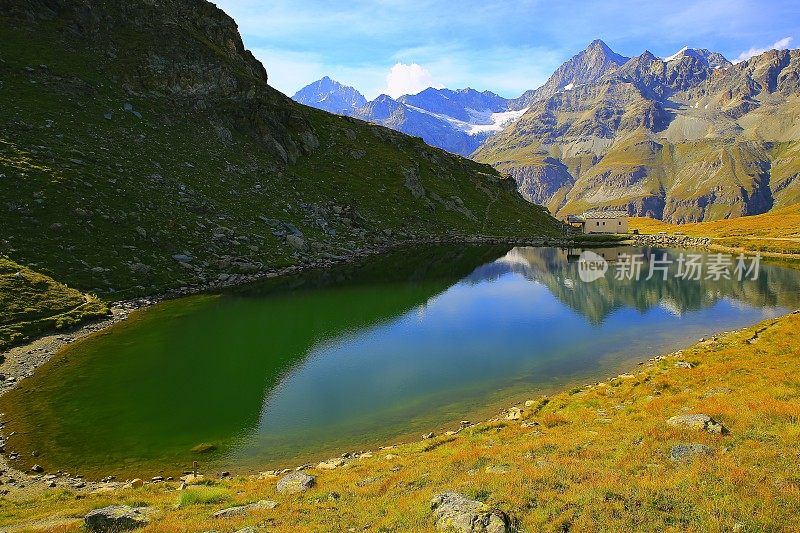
<box><xmin>474</xmin><ymin>44</ymin><xmax>800</xmax><ymax>222</ymax></box>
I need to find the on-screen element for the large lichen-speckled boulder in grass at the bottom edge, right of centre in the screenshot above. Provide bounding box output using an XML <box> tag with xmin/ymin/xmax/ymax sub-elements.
<box><xmin>431</xmin><ymin>492</ymin><xmax>512</xmax><ymax>533</ymax></box>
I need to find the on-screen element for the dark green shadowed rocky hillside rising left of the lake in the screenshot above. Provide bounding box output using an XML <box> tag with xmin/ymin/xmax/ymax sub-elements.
<box><xmin>0</xmin><ymin>0</ymin><xmax>559</xmax><ymax>298</ymax></box>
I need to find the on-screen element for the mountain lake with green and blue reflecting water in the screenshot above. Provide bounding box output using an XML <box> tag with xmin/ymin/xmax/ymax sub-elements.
<box><xmin>0</xmin><ymin>246</ymin><xmax>800</xmax><ymax>478</ymax></box>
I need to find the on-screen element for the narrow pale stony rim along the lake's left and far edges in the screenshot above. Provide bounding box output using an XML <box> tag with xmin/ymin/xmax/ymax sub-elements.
<box><xmin>0</xmin><ymin>235</ymin><xmax>621</xmax><ymax>496</ymax></box>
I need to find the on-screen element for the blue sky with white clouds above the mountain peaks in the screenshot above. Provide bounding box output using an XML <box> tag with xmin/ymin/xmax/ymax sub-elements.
<box><xmin>216</xmin><ymin>0</ymin><xmax>800</xmax><ymax>99</ymax></box>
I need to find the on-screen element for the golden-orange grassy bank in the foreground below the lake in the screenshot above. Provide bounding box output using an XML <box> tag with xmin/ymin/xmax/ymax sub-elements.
<box><xmin>4</xmin><ymin>311</ymin><xmax>800</xmax><ymax>532</ymax></box>
